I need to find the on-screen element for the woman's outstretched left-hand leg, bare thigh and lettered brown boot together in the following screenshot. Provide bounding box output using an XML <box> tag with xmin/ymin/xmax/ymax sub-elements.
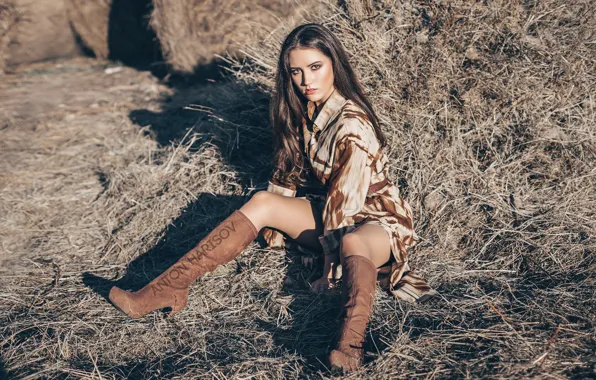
<box><xmin>110</xmin><ymin>192</ymin><xmax>322</xmax><ymax>318</ymax></box>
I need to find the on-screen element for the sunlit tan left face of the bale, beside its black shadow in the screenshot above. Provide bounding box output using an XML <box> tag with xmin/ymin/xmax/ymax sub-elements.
<box><xmin>66</xmin><ymin>0</ymin><xmax>112</xmax><ymax>59</ymax></box>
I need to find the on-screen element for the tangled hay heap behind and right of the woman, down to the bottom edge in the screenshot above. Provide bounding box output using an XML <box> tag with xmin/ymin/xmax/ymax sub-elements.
<box><xmin>229</xmin><ymin>0</ymin><xmax>596</xmax><ymax>378</ymax></box>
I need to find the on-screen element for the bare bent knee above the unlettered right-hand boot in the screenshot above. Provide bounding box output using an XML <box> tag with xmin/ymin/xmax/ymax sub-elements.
<box><xmin>340</xmin><ymin>224</ymin><xmax>391</xmax><ymax>268</ymax></box>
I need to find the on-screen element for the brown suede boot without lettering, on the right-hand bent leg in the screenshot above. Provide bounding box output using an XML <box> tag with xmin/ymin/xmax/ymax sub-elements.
<box><xmin>329</xmin><ymin>255</ymin><xmax>377</xmax><ymax>372</ymax></box>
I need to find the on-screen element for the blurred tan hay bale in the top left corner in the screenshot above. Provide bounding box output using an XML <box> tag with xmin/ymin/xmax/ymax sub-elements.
<box><xmin>2</xmin><ymin>0</ymin><xmax>79</xmax><ymax>66</ymax></box>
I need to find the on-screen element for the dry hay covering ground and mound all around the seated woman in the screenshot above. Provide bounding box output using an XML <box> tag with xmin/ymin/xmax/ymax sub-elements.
<box><xmin>0</xmin><ymin>1</ymin><xmax>596</xmax><ymax>379</ymax></box>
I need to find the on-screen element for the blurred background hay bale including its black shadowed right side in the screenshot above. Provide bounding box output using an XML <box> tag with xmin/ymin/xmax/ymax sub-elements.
<box><xmin>66</xmin><ymin>0</ymin><xmax>161</xmax><ymax>66</ymax></box>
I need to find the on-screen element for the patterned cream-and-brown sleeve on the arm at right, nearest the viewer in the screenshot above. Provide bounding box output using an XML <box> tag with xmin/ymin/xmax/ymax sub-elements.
<box><xmin>319</xmin><ymin>139</ymin><xmax>372</xmax><ymax>255</ymax></box>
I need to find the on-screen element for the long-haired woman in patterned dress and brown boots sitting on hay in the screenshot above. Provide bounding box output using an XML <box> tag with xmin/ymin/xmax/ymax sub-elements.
<box><xmin>110</xmin><ymin>24</ymin><xmax>432</xmax><ymax>370</ymax></box>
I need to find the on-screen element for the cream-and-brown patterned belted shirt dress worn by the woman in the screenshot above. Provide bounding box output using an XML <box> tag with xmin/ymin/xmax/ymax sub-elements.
<box><xmin>268</xmin><ymin>90</ymin><xmax>435</xmax><ymax>302</ymax></box>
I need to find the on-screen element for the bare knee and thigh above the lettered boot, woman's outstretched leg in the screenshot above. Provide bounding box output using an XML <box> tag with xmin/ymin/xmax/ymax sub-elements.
<box><xmin>240</xmin><ymin>191</ymin><xmax>323</xmax><ymax>249</ymax></box>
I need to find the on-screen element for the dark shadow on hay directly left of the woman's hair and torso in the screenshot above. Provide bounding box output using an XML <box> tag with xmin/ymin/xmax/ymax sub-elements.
<box><xmin>129</xmin><ymin>63</ymin><xmax>273</xmax><ymax>188</ymax></box>
